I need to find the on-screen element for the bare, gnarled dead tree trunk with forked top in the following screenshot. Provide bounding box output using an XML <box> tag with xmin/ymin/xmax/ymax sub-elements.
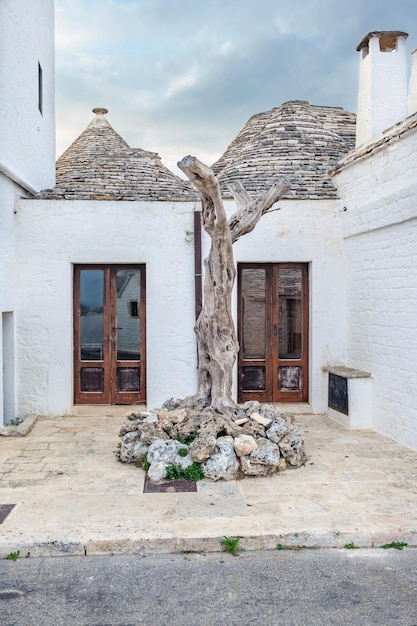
<box><xmin>178</xmin><ymin>156</ymin><xmax>289</xmax><ymax>415</ymax></box>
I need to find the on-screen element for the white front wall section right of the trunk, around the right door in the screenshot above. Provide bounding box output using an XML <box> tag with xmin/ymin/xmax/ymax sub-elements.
<box><xmin>228</xmin><ymin>200</ymin><xmax>346</xmax><ymax>413</ymax></box>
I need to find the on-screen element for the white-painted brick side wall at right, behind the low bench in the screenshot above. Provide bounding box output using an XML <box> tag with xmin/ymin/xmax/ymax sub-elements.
<box><xmin>336</xmin><ymin>120</ymin><xmax>417</xmax><ymax>449</ymax></box>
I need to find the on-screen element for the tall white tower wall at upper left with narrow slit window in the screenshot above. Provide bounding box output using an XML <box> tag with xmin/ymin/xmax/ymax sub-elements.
<box><xmin>0</xmin><ymin>0</ymin><xmax>55</xmax><ymax>191</ymax></box>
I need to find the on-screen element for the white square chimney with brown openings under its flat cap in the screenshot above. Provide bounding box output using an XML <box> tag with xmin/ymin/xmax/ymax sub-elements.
<box><xmin>356</xmin><ymin>31</ymin><xmax>408</xmax><ymax>148</ymax></box>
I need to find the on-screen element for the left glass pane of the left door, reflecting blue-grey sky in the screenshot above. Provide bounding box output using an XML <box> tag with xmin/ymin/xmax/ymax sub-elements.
<box><xmin>80</xmin><ymin>270</ymin><xmax>104</xmax><ymax>361</ymax></box>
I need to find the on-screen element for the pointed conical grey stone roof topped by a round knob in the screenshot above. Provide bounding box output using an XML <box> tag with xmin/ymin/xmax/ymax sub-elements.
<box><xmin>40</xmin><ymin>108</ymin><xmax>198</xmax><ymax>201</ymax></box>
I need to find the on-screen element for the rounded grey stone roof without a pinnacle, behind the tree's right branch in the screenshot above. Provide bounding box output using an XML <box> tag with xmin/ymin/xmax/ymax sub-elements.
<box><xmin>212</xmin><ymin>100</ymin><xmax>356</xmax><ymax>200</ymax></box>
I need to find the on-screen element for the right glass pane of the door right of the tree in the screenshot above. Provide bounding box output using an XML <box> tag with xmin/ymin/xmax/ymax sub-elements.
<box><xmin>278</xmin><ymin>269</ymin><xmax>303</xmax><ymax>359</ymax></box>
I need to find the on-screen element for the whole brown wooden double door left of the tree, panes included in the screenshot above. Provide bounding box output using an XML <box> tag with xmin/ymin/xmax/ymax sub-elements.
<box><xmin>74</xmin><ymin>265</ymin><xmax>146</xmax><ymax>404</ymax></box>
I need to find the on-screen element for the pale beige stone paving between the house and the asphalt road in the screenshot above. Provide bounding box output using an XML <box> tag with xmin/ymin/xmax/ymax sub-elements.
<box><xmin>0</xmin><ymin>415</ymin><xmax>417</xmax><ymax>558</ymax></box>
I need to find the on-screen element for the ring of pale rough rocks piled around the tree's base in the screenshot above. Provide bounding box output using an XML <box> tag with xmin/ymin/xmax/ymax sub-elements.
<box><xmin>117</xmin><ymin>399</ymin><xmax>307</xmax><ymax>482</ymax></box>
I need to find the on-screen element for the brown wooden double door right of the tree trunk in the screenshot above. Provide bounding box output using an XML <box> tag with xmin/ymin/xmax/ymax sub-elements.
<box><xmin>238</xmin><ymin>263</ymin><xmax>309</xmax><ymax>402</ymax></box>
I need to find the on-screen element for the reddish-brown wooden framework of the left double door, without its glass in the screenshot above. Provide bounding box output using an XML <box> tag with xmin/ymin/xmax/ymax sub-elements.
<box><xmin>72</xmin><ymin>263</ymin><xmax>147</xmax><ymax>406</ymax></box>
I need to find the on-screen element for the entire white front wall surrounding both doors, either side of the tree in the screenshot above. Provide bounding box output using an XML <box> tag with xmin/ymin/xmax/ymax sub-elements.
<box><xmin>16</xmin><ymin>200</ymin><xmax>345</xmax><ymax>415</ymax></box>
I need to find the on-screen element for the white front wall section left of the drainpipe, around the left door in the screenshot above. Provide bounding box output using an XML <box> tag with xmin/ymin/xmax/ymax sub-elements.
<box><xmin>16</xmin><ymin>200</ymin><xmax>196</xmax><ymax>415</ymax></box>
